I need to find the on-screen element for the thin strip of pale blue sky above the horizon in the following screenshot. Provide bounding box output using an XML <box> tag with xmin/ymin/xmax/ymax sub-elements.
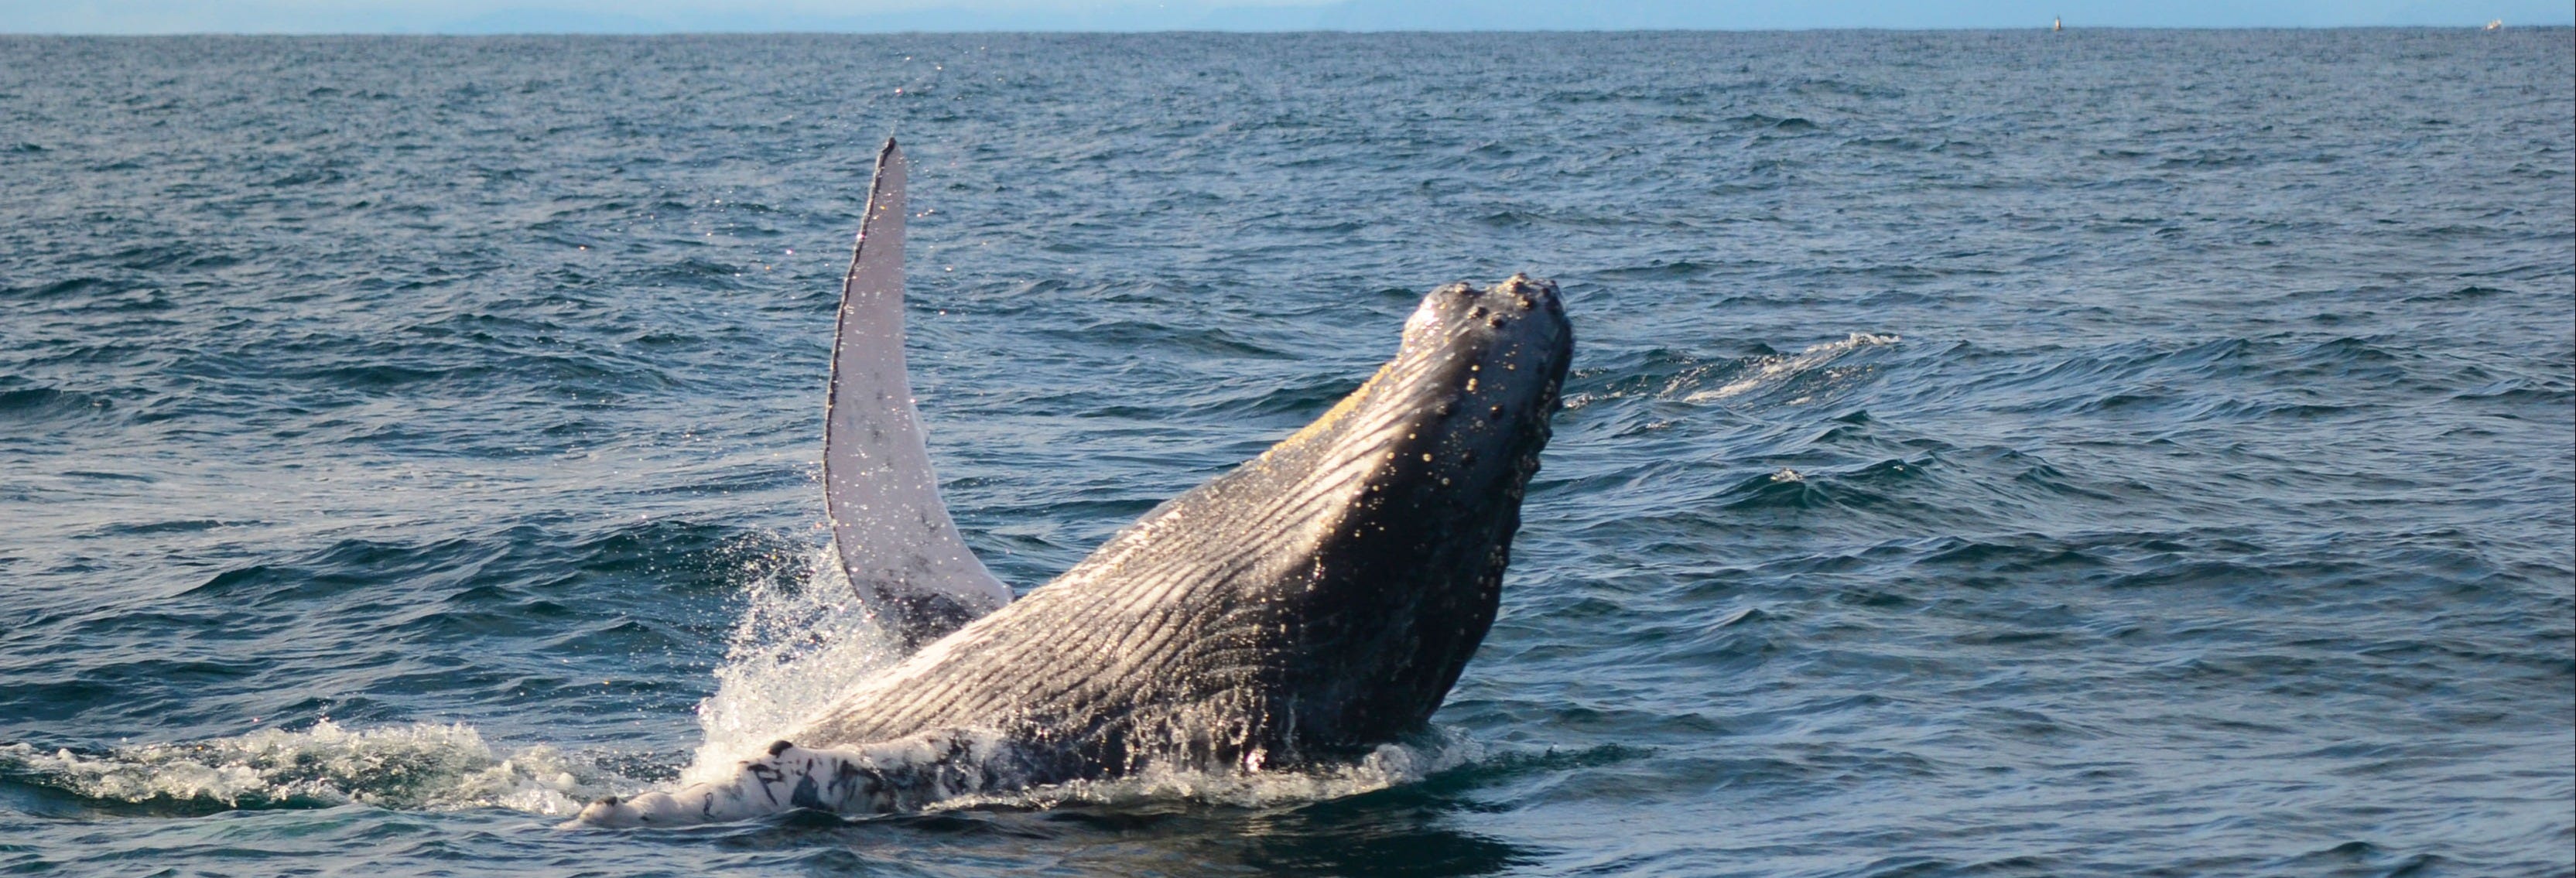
<box><xmin>0</xmin><ymin>0</ymin><xmax>2576</xmax><ymax>33</ymax></box>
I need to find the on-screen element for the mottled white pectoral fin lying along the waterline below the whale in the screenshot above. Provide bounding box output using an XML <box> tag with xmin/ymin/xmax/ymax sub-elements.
<box><xmin>564</xmin><ymin>731</ymin><xmax>1028</xmax><ymax>826</ymax></box>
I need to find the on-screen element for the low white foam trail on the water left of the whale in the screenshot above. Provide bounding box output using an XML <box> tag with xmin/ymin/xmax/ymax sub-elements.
<box><xmin>0</xmin><ymin>719</ymin><xmax>613</xmax><ymax>814</ymax></box>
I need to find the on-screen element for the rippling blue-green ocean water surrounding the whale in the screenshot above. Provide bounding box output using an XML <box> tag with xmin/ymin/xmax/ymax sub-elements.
<box><xmin>0</xmin><ymin>29</ymin><xmax>2576</xmax><ymax>876</ymax></box>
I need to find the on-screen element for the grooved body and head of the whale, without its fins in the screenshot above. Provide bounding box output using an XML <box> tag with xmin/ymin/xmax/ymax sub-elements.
<box><xmin>791</xmin><ymin>275</ymin><xmax>1574</xmax><ymax>785</ymax></box>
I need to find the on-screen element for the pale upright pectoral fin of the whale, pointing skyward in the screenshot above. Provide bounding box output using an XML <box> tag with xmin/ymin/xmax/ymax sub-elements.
<box><xmin>822</xmin><ymin>139</ymin><xmax>1010</xmax><ymax>646</ymax></box>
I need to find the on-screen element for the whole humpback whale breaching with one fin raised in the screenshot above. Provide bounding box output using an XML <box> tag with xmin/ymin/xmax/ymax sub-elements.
<box><xmin>577</xmin><ymin>139</ymin><xmax>1574</xmax><ymax>826</ymax></box>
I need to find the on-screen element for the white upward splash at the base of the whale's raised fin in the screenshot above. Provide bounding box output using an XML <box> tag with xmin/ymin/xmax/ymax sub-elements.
<box><xmin>680</xmin><ymin>546</ymin><xmax>901</xmax><ymax>785</ymax></box>
